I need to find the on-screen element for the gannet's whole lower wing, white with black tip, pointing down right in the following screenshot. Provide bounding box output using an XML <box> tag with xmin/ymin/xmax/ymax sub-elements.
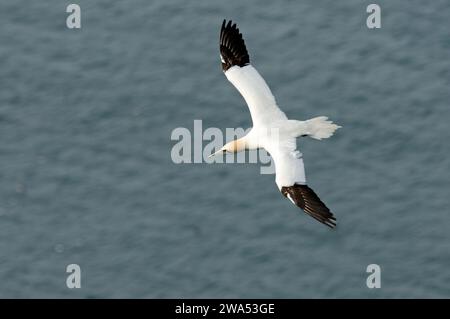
<box><xmin>269</xmin><ymin>140</ymin><xmax>336</xmax><ymax>228</ymax></box>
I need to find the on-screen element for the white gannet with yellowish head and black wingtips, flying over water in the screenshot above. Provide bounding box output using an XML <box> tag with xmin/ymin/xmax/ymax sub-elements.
<box><xmin>210</xmin><ymin>20</ymin><xmax>340</xmax><ymax>228</ymax></box>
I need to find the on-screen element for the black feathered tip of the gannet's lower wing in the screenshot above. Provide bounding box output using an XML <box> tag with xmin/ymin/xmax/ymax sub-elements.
<box><xmin>281</xmin><ymin>184</ymin><xmax>336</xmax><ymax>228</ymax></box>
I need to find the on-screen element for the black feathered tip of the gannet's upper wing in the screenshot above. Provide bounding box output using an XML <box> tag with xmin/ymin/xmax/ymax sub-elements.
<box><xmin>220</xmin><ymin>19</ymin><xmax>250</xmax><ymax>72</ymax></box>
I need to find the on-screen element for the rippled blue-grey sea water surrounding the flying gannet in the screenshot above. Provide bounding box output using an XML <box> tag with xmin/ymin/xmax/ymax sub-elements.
<box><xmin>0</xmin><ymin>0</ymin><xmax>450</xmax><ymax>298</ymax></box>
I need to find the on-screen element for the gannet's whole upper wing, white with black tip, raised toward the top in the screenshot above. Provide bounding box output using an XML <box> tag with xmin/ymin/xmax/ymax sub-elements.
<box><xmin>220</xmin><ymin>20</ymin><xmax>287</xmax><ymax>126</ymax></box>
